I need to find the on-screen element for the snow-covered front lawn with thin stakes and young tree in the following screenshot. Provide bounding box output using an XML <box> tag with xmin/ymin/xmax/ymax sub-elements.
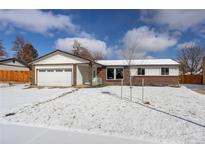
<box><xmin>0</xmin><ymin>86</ymin><xmax>205</xmax><ymax>143</ymax></box>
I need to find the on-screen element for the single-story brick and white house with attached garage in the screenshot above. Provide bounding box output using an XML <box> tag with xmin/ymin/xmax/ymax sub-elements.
<box><xmin>32</xmin><ymin>50</ymin><xmax>179</xmax><ymax>86</ymax></box>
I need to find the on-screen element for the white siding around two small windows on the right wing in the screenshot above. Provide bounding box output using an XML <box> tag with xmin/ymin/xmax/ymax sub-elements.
<box><xmin>131</xmin><ymin>65</ymin><xmax>179</xmax><ymax>76</ymax></box>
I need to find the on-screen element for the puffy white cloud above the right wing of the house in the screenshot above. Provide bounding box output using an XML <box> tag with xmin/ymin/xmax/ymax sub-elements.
<box><xmin>122</xmin><ymin>26</ymin><xmax>177</xmax><ymax>57</ymax></box>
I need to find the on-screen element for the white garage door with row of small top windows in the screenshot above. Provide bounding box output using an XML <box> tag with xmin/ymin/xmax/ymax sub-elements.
<box><xmin>37</xmin><ymin>68</ymin><xmax>72</xmax><ymax>86</ymax></box>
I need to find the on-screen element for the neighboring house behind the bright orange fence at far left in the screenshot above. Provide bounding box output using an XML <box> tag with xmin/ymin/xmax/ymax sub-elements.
<box><xmin>0</xmin><ymin>58</ymin><xmax>29</xmax><ymax>71</ymax></box>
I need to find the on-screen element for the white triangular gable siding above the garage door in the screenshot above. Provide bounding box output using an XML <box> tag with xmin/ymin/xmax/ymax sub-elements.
<box><xmin>34</xmin><ymin>53</ymin><xmax>88</xmax><ymax>64</ymax></box>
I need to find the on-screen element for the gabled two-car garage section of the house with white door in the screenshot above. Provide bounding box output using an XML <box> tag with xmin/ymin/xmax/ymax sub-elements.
<box><xmin>32</xmin><ymin>50</ymin><xmax>92</xmax><ymax>87</ymax></box>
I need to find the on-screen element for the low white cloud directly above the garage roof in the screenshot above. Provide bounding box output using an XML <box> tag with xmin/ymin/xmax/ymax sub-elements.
<box><xmin>55</xmin><ymin>37</ymin><xmax>110</xmax><ymax>54</ymax></box>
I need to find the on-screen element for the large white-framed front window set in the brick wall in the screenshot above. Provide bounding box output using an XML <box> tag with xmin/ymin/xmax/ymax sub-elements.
<box><xmin>107</xmin><ymin>67</ymin><xmax>123</xmax><ymax>80</ymax></box>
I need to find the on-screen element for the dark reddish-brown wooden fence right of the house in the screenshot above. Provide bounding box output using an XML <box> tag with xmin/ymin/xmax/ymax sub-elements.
<box><xmin>179</xmin><ymin>75</ymin><xmax>203</xmax><ymax>84</ymax></box>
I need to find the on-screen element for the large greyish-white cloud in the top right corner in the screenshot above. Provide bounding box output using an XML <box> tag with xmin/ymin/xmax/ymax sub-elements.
<box><xmin>141</xmin><ymin>10</ymin><xmax>205</xmax><ymax>31</ymax></box>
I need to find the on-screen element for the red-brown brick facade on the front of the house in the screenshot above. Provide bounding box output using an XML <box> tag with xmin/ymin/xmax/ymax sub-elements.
<box><xmin>98</xmin><ymin>66</ymin><xmax>179</xmax><ymax>86</ymax></box>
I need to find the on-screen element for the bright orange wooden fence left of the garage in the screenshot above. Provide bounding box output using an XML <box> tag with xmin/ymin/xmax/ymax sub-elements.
<box><xmin>0</xmin><ymin>70</ymin><xmax>31</xmax><ymax>82</ymax></box>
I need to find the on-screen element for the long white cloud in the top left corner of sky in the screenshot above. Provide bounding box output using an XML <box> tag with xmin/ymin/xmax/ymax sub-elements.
<box><xmin>0</xmin><ymin>10</ymin><xmax>79</xmax><ymax>34</ymax></box>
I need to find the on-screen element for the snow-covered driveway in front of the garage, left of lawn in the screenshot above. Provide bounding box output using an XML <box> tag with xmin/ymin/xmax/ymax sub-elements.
<box><xmin>0</xmin><ymin>83</ymin><xmax>73</xmax><ymax>113</ymax></box>
